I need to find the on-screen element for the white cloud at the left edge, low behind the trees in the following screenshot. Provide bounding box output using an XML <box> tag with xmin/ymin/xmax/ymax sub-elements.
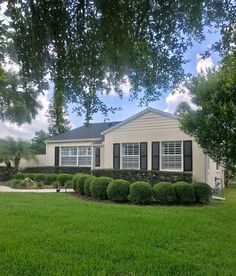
<box><xmin>0</xmin><ymin>92</ymin><xmax>49</xmax><ymax>139</ymax></box>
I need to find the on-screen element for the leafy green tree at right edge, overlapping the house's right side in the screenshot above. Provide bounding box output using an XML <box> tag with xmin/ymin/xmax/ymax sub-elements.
<box><xmin>180</xmin><ymin>51</ymin><xmax>236</xmax><ymax>172</ymax></box>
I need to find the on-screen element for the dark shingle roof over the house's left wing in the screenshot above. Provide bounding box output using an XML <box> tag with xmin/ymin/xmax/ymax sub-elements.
<box><xmin>48</xmin><ymin>122</ymin><xmax>120</xmax><ymax>141</ymax></box>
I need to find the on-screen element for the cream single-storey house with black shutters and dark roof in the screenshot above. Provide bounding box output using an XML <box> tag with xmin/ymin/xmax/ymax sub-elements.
<box><xmin>46</xmin><ymin>108</ymin><xmax>224</xmax><ymax>186</ymax></box>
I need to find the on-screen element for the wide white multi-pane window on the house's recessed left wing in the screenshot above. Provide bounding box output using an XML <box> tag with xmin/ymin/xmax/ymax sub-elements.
<box><xmin>61</xmin><ymin>147</ymin><xmax>92</xmax><ymax>166</ymax></box>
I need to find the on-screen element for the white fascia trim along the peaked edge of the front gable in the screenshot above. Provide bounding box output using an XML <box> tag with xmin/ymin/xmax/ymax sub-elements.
<box><xmin>101</xmin><ymin>107</ymin><xmax>178</xmax><ymax>135</ymax></box>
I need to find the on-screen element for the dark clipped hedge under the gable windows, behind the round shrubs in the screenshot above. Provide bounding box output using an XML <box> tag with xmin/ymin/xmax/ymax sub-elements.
<box><xmin>91</xmin><ymin>169</ymin><xmax>192</xmax><ymax>185</ymax></box>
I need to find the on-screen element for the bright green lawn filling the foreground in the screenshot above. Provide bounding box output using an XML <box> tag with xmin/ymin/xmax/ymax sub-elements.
<box><xmin>0</xmin><ymin>186</ymin><xmax>236</xmax><ymax>276</ymax></box>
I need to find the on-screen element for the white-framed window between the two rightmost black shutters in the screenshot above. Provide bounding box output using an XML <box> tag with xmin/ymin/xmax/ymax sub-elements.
<box><xmin>161</xmin><ymin>141</ymin><xmax>182</xmax><ymax>170</ymax></box>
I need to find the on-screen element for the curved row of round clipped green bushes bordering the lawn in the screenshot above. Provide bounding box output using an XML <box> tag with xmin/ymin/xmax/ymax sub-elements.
<box><xmin>72</xmin><ymin>174</ymin><xmax>211</xmax><ymax>204</ymax></box>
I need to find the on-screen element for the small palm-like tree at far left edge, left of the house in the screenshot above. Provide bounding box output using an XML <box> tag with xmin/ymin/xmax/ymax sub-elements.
<box><xmin>0</xmin><ymin>137</ymin><xmax>34</xmax><ymax>171</ymax></box>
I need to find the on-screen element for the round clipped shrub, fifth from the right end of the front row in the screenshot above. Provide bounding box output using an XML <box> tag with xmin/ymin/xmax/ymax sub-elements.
<box><xmin>107</xmin><ymin>179</ymin><xmax>130</xmax><ymax>202</ymax></box>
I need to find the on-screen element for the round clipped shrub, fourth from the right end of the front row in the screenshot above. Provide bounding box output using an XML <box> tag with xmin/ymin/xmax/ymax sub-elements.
<box><xmin>128</xmin><ymin>181</ymin><xmax>152</xmax><ymax>204</ymax></box>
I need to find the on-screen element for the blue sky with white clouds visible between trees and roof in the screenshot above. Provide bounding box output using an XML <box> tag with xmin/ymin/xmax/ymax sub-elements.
<box><xmin>0</xmin><ymin>28</ymin><xmax>220</xmax><ymax>139</ymax></box>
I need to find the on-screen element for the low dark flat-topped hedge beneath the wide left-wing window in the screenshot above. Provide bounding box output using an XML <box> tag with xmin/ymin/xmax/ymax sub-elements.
<box><xmin>22</xmin><ymin>166</ymin><xmax>91</xmax><ymax>174</ymax></box>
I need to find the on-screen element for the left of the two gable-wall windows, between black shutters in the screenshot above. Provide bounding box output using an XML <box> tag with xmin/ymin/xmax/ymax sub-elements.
<box><xmin>122</xmin><ymin>143</ymin><xmax>139</xmax><ymax>169</ymax></box>
